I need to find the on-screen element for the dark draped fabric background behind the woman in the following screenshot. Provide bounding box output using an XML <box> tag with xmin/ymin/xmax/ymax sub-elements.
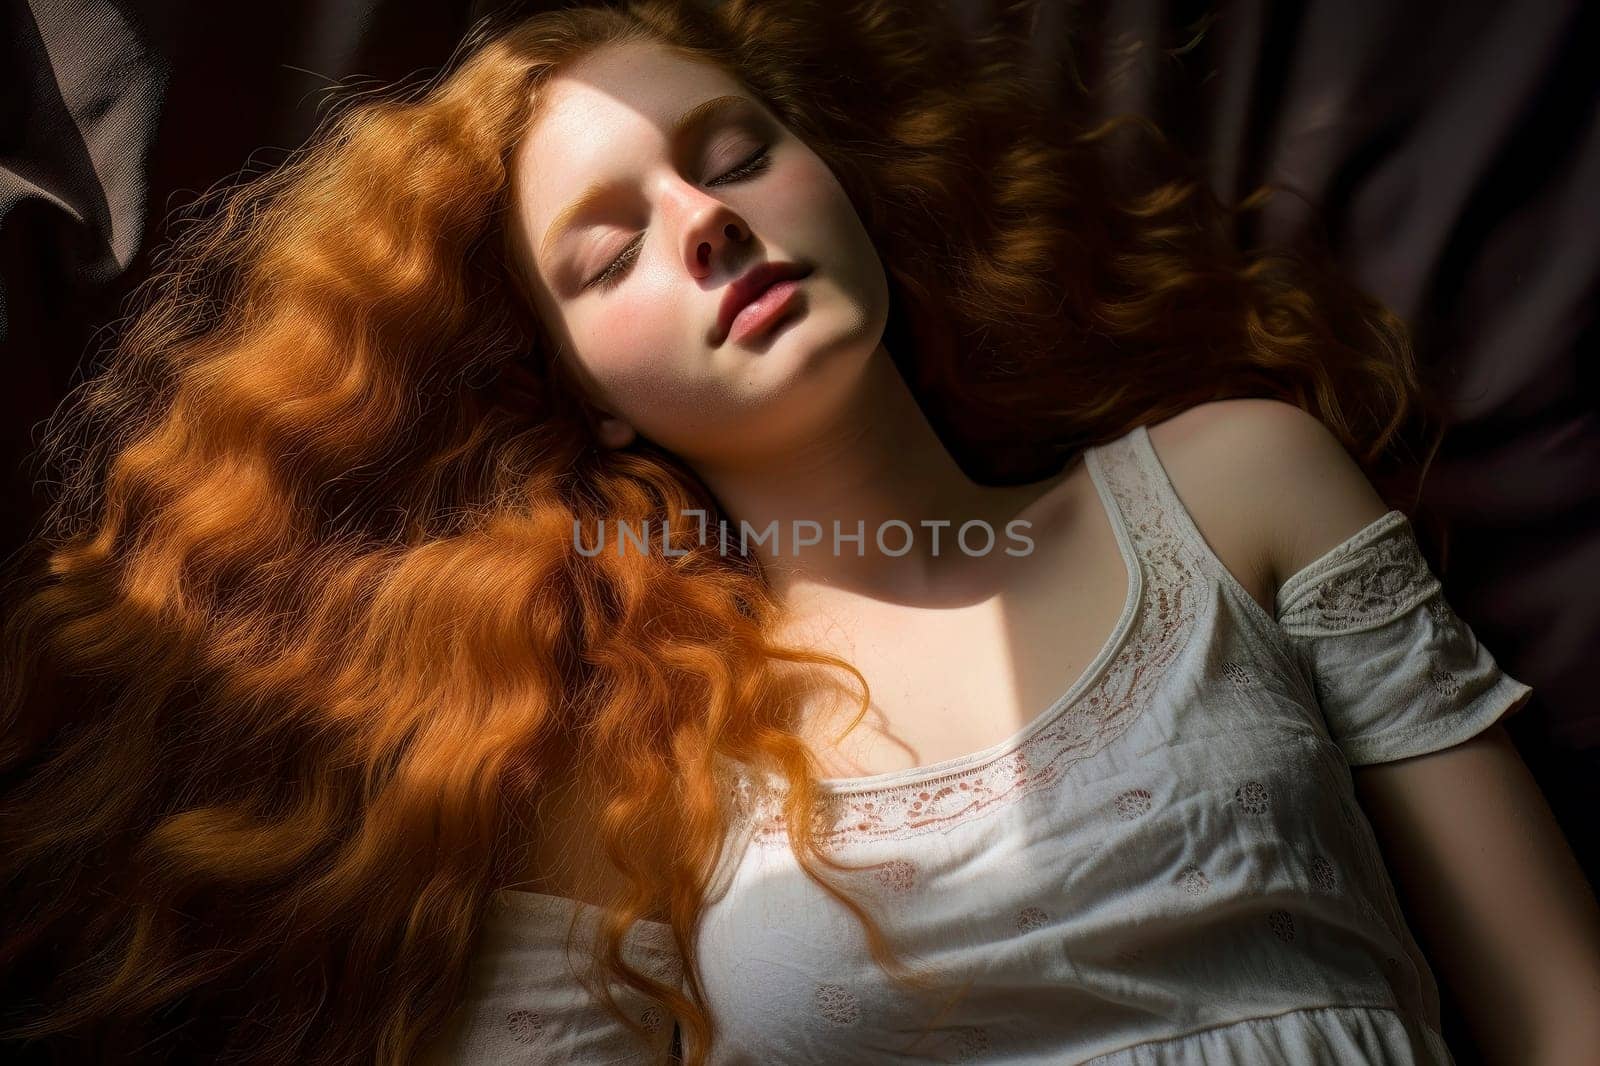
<box><xmin>0</xmin><ymin>0</ymin><xmax>1600</xmax><ymax>1063</ymax></box>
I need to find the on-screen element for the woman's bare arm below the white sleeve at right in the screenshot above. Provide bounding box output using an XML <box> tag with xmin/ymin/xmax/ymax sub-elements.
<box><xmin>1352</xmin><ymin>723</ymin><xmax>1600</xmax><ymax>1064</ymax></box>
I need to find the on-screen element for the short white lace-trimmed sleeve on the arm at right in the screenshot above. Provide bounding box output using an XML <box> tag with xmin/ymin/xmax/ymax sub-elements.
<box><xmin>1277</xmin><ymin>511</ymin><xmax>1533</xmax><ymax>767</ymax></box>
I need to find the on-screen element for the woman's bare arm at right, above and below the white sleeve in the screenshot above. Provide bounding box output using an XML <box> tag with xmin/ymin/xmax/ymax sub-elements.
<box><xmin>1202</xmin><ymin>399</ymin><xmax>1600</xmax><ymax>1064</ymax></box>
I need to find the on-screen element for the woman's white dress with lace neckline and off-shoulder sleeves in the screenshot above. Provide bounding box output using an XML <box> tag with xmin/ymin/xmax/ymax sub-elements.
<box><xmin>430</xmin><ymin>427</ymin><xmax>1531</xmax><ymax>1066</ymax></box>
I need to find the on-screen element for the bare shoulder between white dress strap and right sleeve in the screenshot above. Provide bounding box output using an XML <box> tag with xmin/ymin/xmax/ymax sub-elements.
<box><xmin>1149</xmin><ymin>397</ymin><xmax>1389</xmax><ymax>603</ymax></box>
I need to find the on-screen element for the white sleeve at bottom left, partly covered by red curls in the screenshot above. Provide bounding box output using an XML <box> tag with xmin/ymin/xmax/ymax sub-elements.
<box><xmin>422</xmin><ymin>892</ymin><xmax>683</xmax><ymax>1066</ymax></box>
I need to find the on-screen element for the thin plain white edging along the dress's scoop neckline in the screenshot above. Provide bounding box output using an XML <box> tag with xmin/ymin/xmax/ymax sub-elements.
<box><xmin>745</xmin><ymin>442</ymin><xmax>1146</xmax><ymax>795</ymax></box>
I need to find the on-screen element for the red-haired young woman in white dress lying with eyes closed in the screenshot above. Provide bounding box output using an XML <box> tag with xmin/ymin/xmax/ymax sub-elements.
<box><xmin>0</xmin><ymin>2</ymin><xmax>1600</xmax><ymax>1063</ymax></box>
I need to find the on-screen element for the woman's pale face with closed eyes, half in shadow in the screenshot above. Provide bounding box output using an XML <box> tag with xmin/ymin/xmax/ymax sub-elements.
<box><xmin>514</xmin><ymin>43</ymin><xmax>888</xmax><ymax>466</ymax></box>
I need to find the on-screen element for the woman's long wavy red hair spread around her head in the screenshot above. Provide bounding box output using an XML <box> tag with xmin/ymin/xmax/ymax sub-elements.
<box><xmin>0</xmin><ymin>0</ymin><xmax>1432</xmax><ymax>1064</ymax></box>
